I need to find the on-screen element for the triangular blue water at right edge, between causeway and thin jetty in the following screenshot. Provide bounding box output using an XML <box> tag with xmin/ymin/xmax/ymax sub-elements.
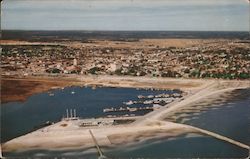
<box><xmin>168</xmin><ymin>89</ymin><xmax>250</xmax><ymax>145</ymax></box>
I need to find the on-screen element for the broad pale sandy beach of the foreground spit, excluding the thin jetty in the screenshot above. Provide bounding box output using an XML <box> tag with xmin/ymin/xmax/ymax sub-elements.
<box><xmin>2</xmin><ymin>121</ymin><xmax>195</xmax><ymax>151</ymax></box>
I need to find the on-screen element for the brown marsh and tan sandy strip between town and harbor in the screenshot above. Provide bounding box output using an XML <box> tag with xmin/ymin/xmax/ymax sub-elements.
<box><xmin>1</xmin><ymin>75</ymin><xmax>250</xmax><ymax>104</ymax></box>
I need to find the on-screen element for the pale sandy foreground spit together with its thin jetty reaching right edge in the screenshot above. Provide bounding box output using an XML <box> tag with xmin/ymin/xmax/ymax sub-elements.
<box><xmin>2</xmin><ymin>118</ymin><xmax>250</xmax><ymax>153</ymax></box>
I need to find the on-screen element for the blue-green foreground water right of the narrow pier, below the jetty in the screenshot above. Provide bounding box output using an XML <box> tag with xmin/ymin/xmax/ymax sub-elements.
<box><xmin>105</xmin><ymin>136</ymin><xmax>248</xmax><ymax>158</ymax></box>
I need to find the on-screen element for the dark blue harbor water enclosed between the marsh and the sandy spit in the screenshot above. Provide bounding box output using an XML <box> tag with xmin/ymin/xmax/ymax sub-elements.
<box><xmin>1</xmin><ymin>87</ymin><xmax>176</xmax><ymax>142</ymax></box>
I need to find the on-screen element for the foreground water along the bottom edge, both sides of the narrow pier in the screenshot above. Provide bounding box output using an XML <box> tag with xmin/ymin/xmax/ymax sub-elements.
<box><xmin>3</xmin><ymin>136</ymin><xmax>248</xmax><ymax>159</ymax></box>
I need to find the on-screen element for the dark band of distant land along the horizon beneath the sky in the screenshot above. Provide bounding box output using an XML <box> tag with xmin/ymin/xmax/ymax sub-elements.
<box><xmin>2</xmin><ymin>30</ymin><xmax>249</xmax><ymax>42</ymax></box>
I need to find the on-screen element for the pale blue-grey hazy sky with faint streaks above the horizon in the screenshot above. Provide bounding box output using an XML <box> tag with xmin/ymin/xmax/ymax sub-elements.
<box><xmin>1</xmin><ymin>0</ymin><xmax>250</xmax><ymax>31</ymax></box>
